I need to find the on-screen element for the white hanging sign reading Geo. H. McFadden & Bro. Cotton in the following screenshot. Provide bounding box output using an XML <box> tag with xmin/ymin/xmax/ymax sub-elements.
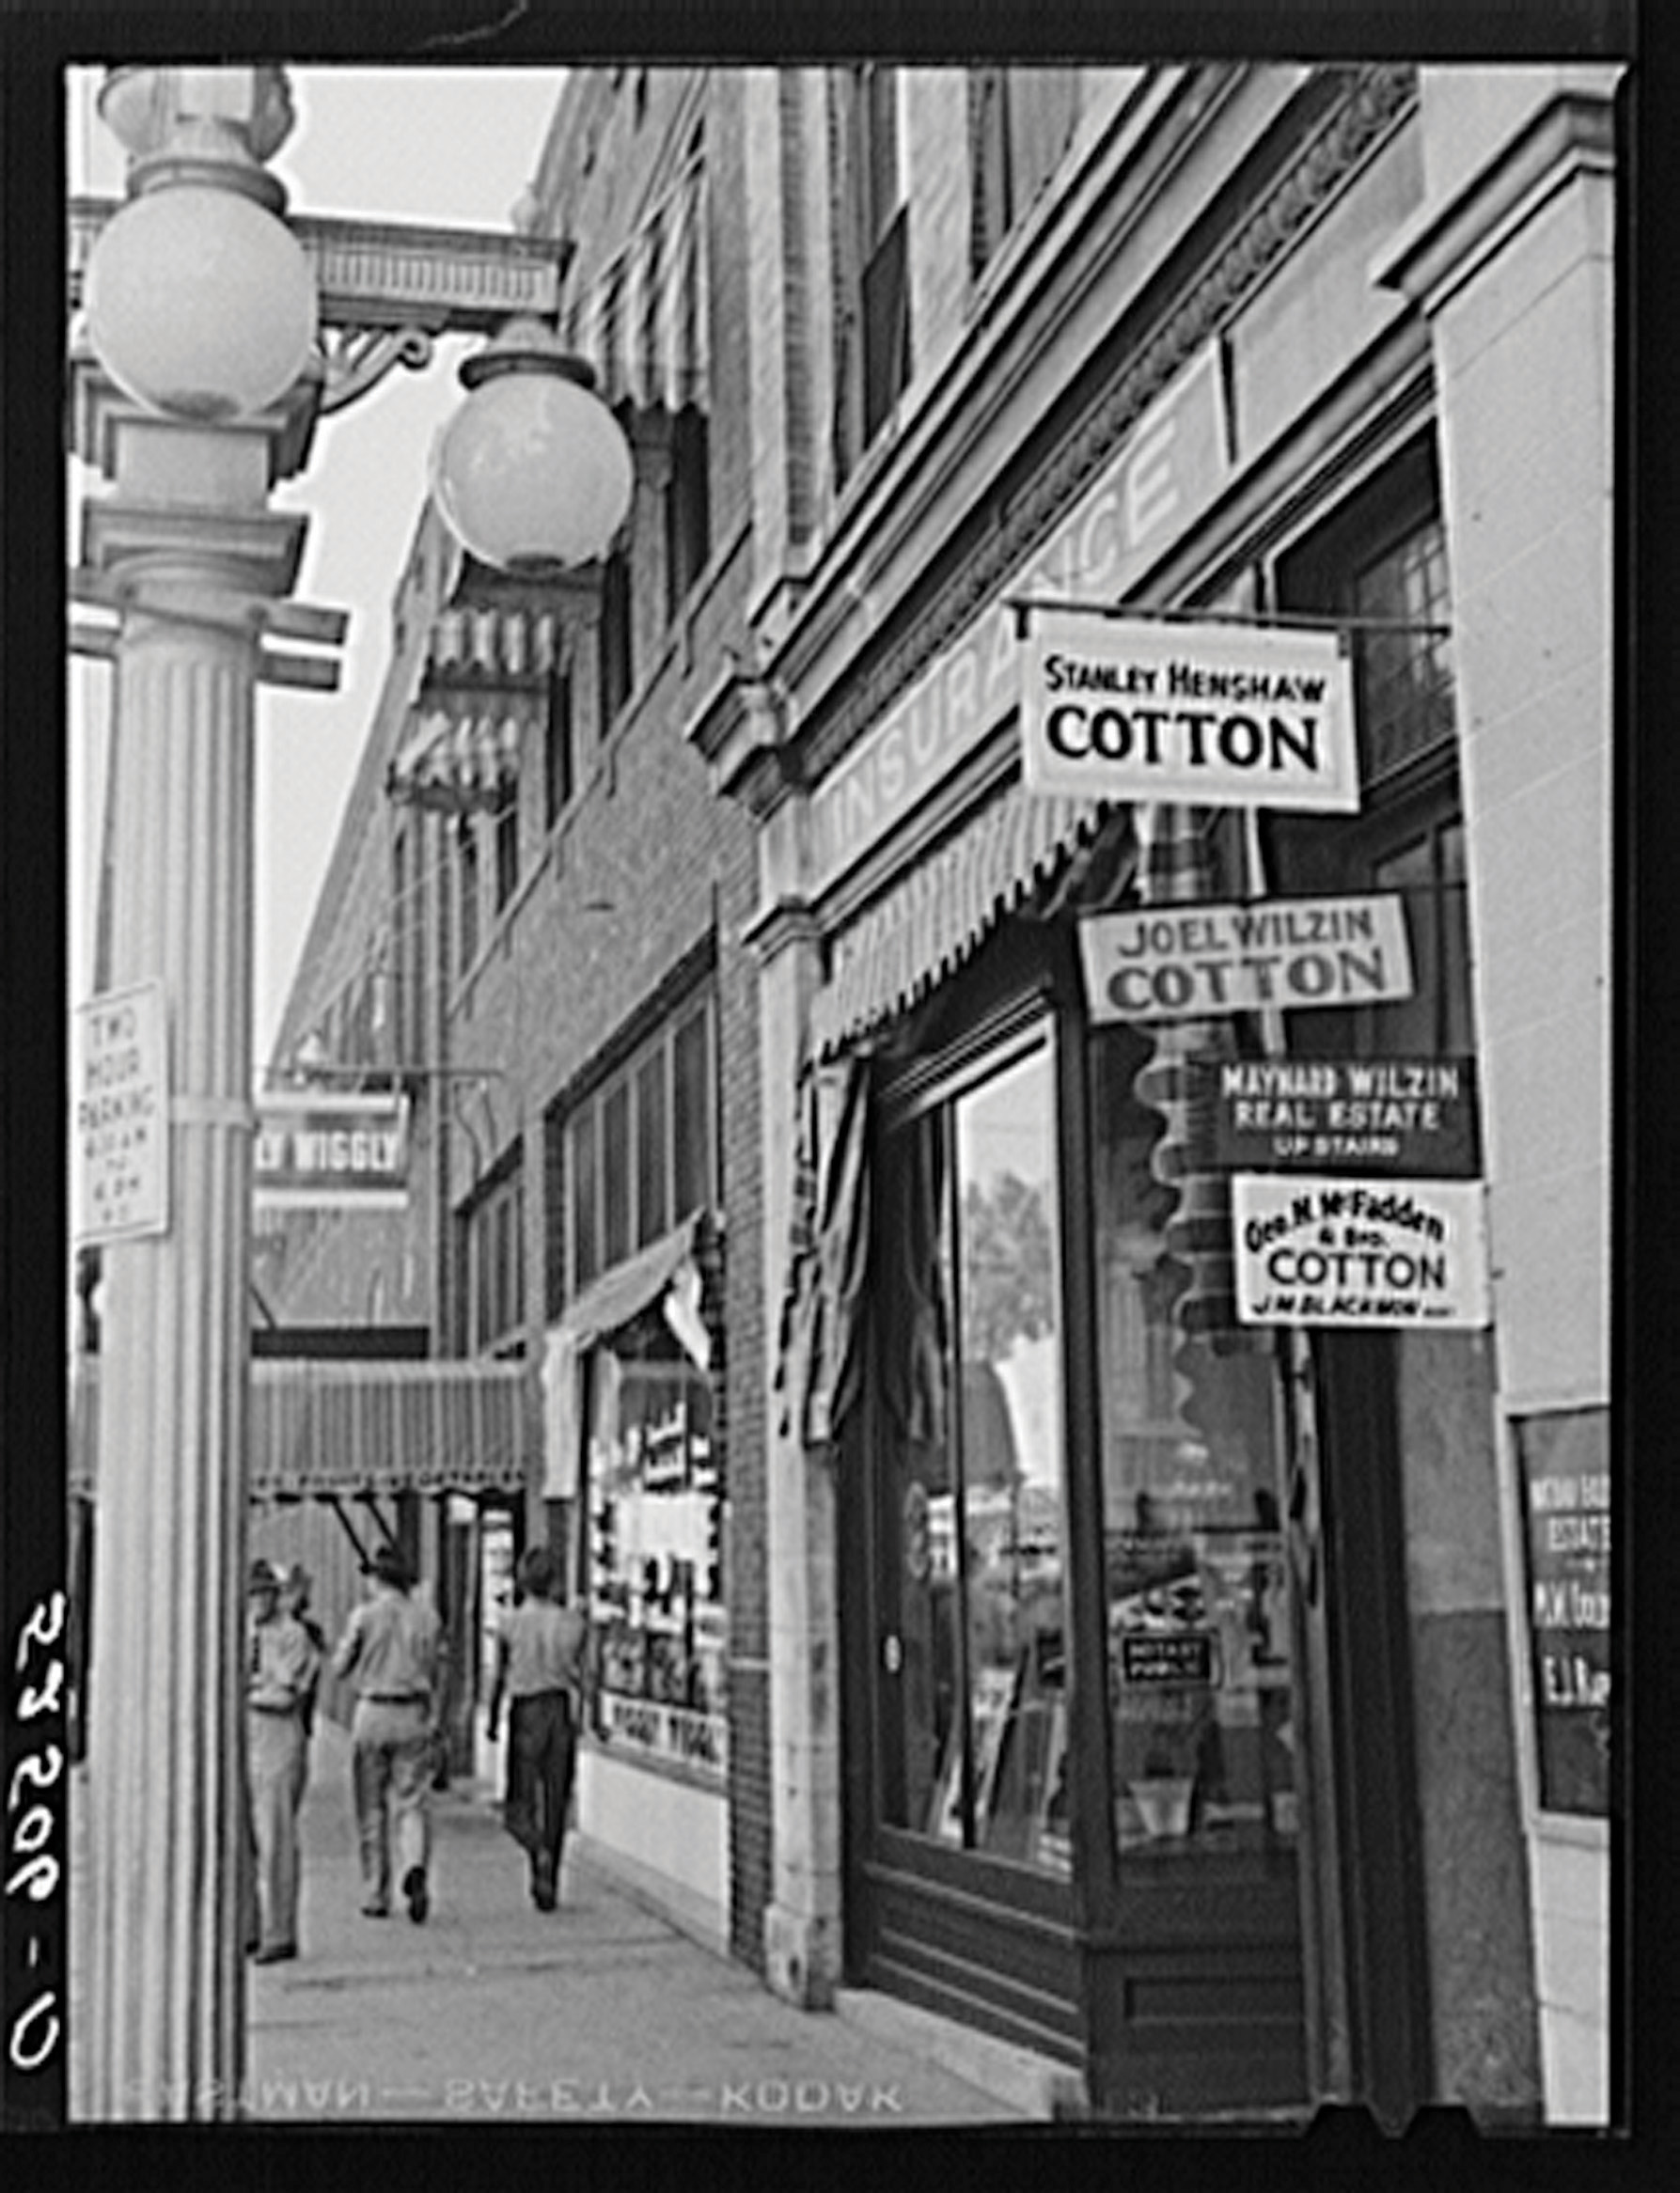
<box><xmin>1231</xmin><ymin>1173</ymin><xmax>1491</xmax><ymax>1331</ymax></box>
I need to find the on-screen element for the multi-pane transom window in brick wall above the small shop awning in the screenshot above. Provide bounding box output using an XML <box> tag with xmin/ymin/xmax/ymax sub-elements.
<box><xmin>548</xmin><ymin>995</ymin><xmax>717</xmax><ymax>1311</ymax></box>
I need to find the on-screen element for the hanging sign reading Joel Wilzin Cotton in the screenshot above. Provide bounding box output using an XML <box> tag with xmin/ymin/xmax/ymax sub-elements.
<box><xmin>1079</xmin><ymin>890</ymin><xmax>1412</xmax><ymax>1022</ymax></box>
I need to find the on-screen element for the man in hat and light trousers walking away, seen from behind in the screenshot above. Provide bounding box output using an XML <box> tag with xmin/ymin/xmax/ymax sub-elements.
<box><xmin>334</xmin><ymin>1546</ymin><xmax>443</xmax><ymax>1925</ymax></box>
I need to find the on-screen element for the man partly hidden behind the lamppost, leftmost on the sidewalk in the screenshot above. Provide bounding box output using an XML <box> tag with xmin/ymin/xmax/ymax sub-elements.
<box><xmin>245</xmin><ymin>1561</ymin><xmax>321</xmax><ymax>1965</ymax></box>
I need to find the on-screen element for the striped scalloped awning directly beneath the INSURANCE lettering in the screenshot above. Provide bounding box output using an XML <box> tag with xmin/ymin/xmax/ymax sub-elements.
<box><xmin>811</xmin><ymin>785</ymin><xmax>1112</xmax><ymax>1057</ymax></box>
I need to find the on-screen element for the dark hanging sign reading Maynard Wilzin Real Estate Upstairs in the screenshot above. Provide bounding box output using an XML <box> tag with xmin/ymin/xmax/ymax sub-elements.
<box><xmin>1201</xmin><ymin>1057</ymin><xmax>1481</xmax><ymax>1180</ymax></box>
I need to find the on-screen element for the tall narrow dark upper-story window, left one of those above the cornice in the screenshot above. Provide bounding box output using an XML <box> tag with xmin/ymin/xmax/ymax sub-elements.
<box><xmin>829</xmin><ymin>64</ymin><xmax>910</xmax><ymax>485</ymax></box>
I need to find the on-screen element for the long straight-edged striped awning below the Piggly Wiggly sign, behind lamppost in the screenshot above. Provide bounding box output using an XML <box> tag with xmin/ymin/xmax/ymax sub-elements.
<box><xmin>71</xmin><ymin>1355</ymin><xmax>542</xmax><ymax>1500</ymax></box>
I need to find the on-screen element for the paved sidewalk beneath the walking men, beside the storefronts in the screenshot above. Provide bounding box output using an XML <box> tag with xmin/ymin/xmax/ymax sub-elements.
<box><xmin>245</xmin><ymin>1721</ymin><xmax>1039</xmax><ymax>2132</ymax></box>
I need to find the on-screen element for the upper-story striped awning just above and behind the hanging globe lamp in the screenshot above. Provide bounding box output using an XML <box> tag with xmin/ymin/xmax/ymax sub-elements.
<box><xmin>559</xmin><ymin>160</ymin><xmax>711</xmax><ymax>413</ymax></box>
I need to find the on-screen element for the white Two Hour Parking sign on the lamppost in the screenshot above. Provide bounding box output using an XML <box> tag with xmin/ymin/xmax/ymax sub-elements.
<box><xmin>71</xmin><ymin>982</ymin><xmax>169</xmax><ymax>1244</ymax></box>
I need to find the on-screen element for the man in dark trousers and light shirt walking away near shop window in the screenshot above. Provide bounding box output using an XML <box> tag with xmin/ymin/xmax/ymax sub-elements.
<box><xmin>489</xmin><ymin>1546</ymin><xmax>588</xmax><ymax>1912</ymax></box>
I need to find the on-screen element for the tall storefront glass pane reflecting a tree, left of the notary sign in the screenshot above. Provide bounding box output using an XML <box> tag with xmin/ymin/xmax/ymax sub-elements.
<box><xmin>884</xmin><ymin>1035</ymin><xmax>1068</xmax><ymax>1872</ymax></box>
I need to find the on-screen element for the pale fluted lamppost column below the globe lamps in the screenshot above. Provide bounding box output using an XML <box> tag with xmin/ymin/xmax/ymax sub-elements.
<box><xmin>72</xmin><ymin>390</ymin><xmax>303</xmax><ymax>2121</ymax></box>
